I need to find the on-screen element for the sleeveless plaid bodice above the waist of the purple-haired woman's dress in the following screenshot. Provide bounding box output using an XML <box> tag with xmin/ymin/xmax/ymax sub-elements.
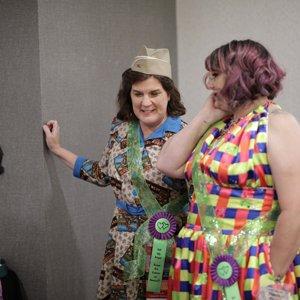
<box><xmin>185</xmin><ymin>101</ymin><xmax>278</xmax><ymax>232</ymax></box>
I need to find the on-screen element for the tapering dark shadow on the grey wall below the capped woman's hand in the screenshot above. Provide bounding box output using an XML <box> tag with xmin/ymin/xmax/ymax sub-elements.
<box><xmin>44</xmin><ymin>143</ymin><xmax>86</xmax><ymax>300</ymax></box>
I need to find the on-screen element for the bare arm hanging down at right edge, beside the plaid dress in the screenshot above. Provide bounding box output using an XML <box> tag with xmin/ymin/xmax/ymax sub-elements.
<box><xmin>268</xmin><ymin>111</ymin><xmax>300</xmax><ymax>276</ymax></box>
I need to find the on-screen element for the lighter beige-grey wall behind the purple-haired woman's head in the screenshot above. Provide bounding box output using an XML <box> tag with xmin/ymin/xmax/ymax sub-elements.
<box><xmin>176</xmin><ymin>0</ymin><xmax>300</xmax><ymax>121</ymax></box>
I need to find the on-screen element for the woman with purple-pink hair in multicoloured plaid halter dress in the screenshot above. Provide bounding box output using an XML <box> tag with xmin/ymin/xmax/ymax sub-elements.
<box><xmin>157</xmin><ymin>40</ymin><xmax>300</xmax><ymax>300</ymax></box>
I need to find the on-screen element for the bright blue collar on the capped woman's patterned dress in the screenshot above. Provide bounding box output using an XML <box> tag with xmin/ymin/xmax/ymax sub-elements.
<box><xmin>140</xmin><ymin>117</ymin><xmax>181</xmax><ymax>146</ymax></box>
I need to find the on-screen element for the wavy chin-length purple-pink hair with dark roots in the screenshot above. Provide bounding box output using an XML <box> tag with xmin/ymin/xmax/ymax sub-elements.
<box><xmin>204</xmin><ymin>40</ymin><xmax>285</xmax><ymax>106</ymax></box>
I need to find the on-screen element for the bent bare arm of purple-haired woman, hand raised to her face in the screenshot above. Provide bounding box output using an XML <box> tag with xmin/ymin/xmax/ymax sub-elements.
<box><xmin>157</xmin><ymin>94</ymin><xmax>226</xmax><ymax>178</ymax></box>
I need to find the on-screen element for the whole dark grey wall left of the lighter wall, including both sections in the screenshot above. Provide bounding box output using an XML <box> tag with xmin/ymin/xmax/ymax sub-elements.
<box><xmin>0</xmin><ymin>0</ymin><xmax>177</xmax><ymax>300</ymax></box>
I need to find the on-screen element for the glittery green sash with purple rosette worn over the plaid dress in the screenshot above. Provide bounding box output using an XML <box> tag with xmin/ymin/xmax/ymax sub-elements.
<box><xmin>192</xmin><ymin>125</ymin><xmax>279</xmax><ymax>300</ymax></box>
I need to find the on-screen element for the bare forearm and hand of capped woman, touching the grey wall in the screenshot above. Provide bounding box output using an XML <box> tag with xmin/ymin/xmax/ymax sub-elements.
<box><xmin>43</xmin><ymin>120</ymin><xmax>77</xmax><ymax>170</ymax></box>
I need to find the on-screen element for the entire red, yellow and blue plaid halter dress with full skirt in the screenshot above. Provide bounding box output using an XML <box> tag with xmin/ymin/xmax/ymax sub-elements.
<box><xmin>169</xmin><ymin>102</ymin><xmax>300</xmax><ymax>300</ymax></box>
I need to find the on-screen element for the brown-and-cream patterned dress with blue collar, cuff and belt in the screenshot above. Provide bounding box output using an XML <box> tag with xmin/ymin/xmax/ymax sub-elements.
<box><xmin>74</xmin><ymin>117</ymin><xmax>188</xmax><ymax>300</ymax></box>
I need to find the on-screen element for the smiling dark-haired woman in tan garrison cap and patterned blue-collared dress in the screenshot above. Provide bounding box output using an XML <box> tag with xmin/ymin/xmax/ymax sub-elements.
<box><xmin>43</xmin><ymin>47</ymin><xmax>188</xmax><ymax>300</ymax></box>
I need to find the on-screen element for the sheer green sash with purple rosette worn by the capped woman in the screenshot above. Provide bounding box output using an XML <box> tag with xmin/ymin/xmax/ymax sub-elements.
<box><xmin>124</xmin><ymin>122</ymin><xmax>188</xmax><ymax>292</ymax></box>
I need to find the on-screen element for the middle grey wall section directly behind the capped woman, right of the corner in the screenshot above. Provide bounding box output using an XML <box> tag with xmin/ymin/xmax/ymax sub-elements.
<box><xmin>38</xmin><ymin>0</ymin><xmax>177</xmax><ymax>300</ymax></box>
